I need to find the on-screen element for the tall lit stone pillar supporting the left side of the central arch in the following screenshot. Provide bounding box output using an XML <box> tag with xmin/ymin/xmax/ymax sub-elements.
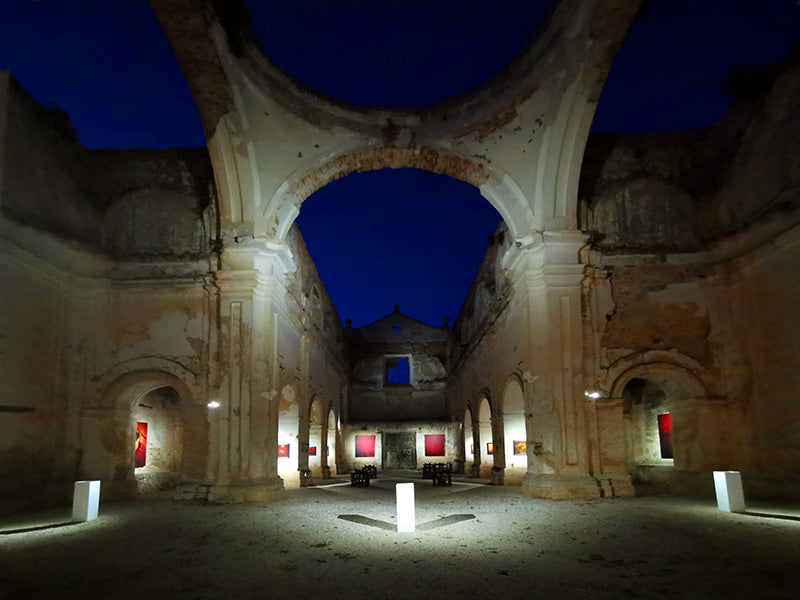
<box><xmin>208</xmin><ymin>242</ymin><xmax>287</xmax><ymax>502</ymax></box>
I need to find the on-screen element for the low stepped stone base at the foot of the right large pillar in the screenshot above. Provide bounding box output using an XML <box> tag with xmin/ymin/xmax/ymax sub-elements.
<box><xmin>520</xmin><ymin>474</ymin><xmax>633</xmax><ymax>500</ymax></box>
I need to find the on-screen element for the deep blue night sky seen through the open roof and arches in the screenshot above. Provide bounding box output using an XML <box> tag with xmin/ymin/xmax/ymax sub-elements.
<box><xmin>0</xmin><ymin>0</ymin><xmax>800</xmax><ymax>326</ymax></box>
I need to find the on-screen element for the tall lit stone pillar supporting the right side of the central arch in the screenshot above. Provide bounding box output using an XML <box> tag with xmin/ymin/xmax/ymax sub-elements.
<box><xmin>512</xmin><ymin>231</ymin><xmax>600</xmax><ymax>498</ymax></box>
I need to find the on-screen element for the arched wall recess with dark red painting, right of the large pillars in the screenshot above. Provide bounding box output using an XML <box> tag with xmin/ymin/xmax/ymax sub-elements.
<box><xmin>611</xmin><ymin>362</ymin><xmax>708</xmax><ymax>494</ymax></box>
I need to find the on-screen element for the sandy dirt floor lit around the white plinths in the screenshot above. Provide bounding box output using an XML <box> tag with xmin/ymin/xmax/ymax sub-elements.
<box><xmin>0</xmin><ymin>477</ymin><xmax>800</xmax><ymax>600</ymax></box>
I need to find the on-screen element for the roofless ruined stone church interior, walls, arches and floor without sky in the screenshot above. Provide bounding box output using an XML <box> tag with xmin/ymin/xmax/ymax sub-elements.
<box><xmin>0</xmin><ymin>0</ymin><xmax>800</xmax><ymax>599</ymax></box>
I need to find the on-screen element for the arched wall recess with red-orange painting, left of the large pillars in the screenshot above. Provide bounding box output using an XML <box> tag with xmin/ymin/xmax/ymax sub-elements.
<box><xmin>81</xmin><ymin>369</ymin><xmax>203</xmax><ymax>499</ymax></box>
